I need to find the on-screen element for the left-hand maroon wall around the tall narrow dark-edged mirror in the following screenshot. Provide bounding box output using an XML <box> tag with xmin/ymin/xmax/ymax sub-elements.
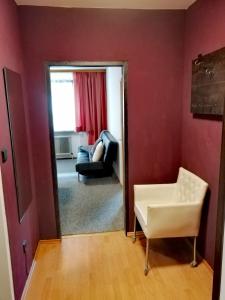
<box><xmin>0</xmin><ymin>0</ymin><xmax>39</xmax><ymax>299</ymax></box>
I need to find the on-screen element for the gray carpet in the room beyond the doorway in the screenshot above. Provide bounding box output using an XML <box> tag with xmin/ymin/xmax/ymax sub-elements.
<box><xmin>57</xmin><ymin>160</ymin><xmax>124</xmax><ymax>235</ymax></box>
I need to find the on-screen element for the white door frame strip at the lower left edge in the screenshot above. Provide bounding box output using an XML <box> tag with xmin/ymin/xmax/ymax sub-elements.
<box><xmin>0</xmin><ymin>168</ymin><xmax>15</xmax><ymax>300</ymax></box>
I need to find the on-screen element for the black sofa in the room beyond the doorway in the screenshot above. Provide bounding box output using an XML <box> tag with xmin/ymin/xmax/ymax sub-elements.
<box><xmin>75</xmin><ymin>130</ymin><xmax>118</xmax><ymax>179</ymax></box>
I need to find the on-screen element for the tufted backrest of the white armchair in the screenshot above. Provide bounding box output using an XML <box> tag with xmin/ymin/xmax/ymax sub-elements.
<box><xmin>177</xmin><ymin>167</ymin><xmax>208</xmax><ymax>203</ymax></box>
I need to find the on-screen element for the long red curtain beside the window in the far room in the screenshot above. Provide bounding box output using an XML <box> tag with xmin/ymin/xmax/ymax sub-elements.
<box><xmin>73</xmin><ymin>72</ymin><xmax>107</xmax><ymax>144</ymax></box>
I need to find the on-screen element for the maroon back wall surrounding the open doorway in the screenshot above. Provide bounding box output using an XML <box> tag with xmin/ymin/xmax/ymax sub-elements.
<box><xmin>19</xmin><ymin>6</ymin><xmax>184</xmax><ymax>238</ymax></box>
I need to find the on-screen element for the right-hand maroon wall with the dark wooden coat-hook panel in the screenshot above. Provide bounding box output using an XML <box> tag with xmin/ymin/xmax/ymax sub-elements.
<box><xmin>182</xmin><ymin>0</ymin><xmax>225</xmax><ymax>266</ymax></box>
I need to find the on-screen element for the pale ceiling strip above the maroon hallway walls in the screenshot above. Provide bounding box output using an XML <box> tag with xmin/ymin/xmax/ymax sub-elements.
<box><xmin>15</xmin><ymin>0</ymin><xmax>196</xmax><ymax>9</ymax></box>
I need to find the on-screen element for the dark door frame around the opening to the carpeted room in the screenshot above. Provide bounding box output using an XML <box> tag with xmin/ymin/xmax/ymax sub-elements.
<box><xmin>44</xmin><ymin>60</ymin><xmax>129</xmax><ymax>238</ymax></box>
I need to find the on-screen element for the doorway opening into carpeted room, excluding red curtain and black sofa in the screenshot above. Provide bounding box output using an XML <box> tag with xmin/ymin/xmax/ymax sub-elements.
<box><xmin>46</xmin><ymin>62</ymin><xmax>127</xmax><ymax>237</ymax></box>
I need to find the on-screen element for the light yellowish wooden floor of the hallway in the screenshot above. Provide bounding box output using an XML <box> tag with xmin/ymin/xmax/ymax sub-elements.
<box><xmin>23</xmin><ymin>232</ymin><xmax>212</xmax><ymax>300</ymax></box>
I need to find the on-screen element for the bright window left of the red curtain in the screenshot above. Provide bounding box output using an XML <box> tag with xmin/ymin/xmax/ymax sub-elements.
<box><xmin>50</xmin><ymin>72</ymin><xmax>75</xmax><ymax>131</ymax></box>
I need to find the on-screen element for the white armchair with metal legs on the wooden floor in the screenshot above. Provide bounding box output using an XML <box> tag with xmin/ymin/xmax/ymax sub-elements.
<box><xmin>133</xmin><ymin>168</ymin><xmax>208</xmax><ymax>275</ymax></box>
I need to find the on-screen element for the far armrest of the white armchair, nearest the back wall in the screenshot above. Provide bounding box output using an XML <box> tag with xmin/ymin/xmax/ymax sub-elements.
<box><xmin>134</xmin><ymin>183</ymin><xmax>177</xmax><ymax>203</ymax></box>
